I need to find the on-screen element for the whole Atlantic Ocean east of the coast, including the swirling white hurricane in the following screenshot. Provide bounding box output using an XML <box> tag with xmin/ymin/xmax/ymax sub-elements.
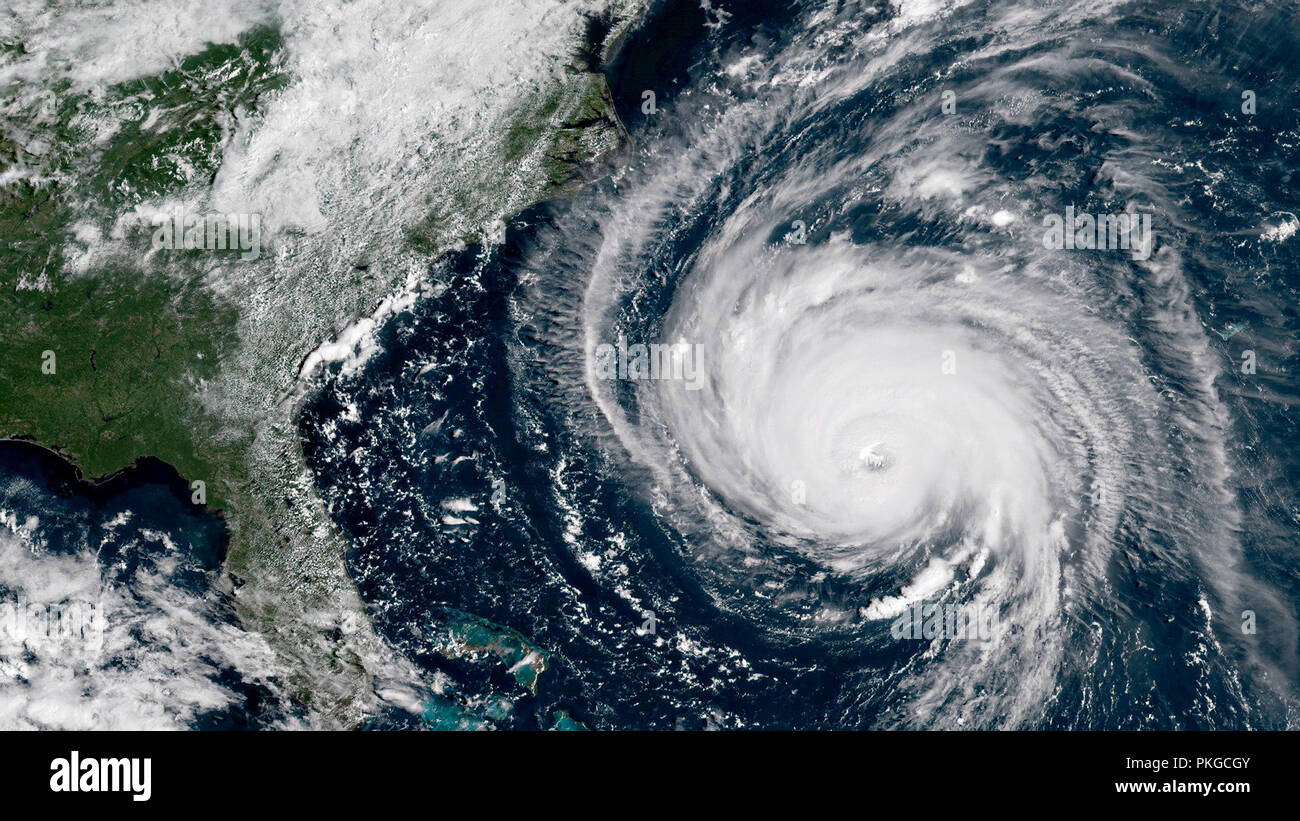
<box><xmin>302</xmin><ymin>0</ymin><xmax>1300</xmax><ymax>729</ymax></box>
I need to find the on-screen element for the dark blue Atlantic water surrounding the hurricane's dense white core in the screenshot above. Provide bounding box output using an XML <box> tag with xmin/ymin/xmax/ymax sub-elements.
<box><xmin>302</xmin><ymin>3</ymin><xmax>1300</xmax><ymax>729</ymax></box>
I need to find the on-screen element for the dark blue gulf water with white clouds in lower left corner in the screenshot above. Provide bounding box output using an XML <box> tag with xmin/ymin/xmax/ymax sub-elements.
<box><xmin>0</xmin><ymin>442</ymin><xmax>287</xmax><ymax>730</ymax></box>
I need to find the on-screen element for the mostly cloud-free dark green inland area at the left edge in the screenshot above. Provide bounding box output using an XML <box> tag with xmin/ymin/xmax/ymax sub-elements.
<box><xmin>0</xmin><ymin>27</ymin><xmax>287</xmax><ymax>508</ymax></box>
